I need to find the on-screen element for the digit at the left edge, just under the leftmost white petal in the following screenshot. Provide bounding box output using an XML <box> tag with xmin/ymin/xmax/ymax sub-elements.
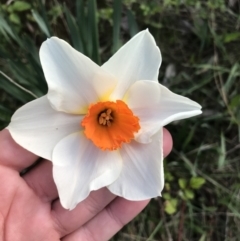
<box><xmin>0</xmin><ymin>129</ymin><xmax>38</xmax><ymax>172</ymax></box>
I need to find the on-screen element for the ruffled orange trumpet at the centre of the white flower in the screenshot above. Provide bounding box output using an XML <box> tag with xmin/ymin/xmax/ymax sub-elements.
<box><xmin>81</xmin><ymin>100</ymin><xmax>140</xmax><ymax>150</ymax></box>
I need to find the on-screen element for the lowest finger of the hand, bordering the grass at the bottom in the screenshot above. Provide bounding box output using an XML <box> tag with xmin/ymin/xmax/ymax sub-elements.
<box><xmin>62</xmin><ymin>197</ymin><xmax>149</xmax><ymax>241</ymax></box>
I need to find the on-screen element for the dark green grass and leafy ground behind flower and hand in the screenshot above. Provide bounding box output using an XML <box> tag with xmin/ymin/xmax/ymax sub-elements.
<box><xmin>0</xmin><ymin>0</ymin><xmax>240</xmax><ymax>241</ymax></box>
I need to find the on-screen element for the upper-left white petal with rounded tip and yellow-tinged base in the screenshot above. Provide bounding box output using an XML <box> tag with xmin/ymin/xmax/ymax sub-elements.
<box><xmin>40</xmin><ymin>37</ymin><xmax>116</xmax><ymax>114</ymax></box>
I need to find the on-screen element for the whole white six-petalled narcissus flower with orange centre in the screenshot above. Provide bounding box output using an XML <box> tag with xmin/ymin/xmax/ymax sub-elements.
<box><xmin>8</xmin><ymin>30</ymin><xmax>201</xmax><ymax>209</ymax></box>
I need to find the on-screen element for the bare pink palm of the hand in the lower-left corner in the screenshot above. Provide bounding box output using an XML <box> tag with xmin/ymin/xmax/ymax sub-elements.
<box><xmin>0</xmin><ymin>166</ymin><xmax>60</xmax><ymax>241</ymax></box>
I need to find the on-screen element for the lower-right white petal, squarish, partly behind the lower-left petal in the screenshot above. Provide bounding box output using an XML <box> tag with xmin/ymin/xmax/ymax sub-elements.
<box><xmin>108</xmin><ymin>129</ymin><xmax>164</xmax><ymax>201</ymax></box>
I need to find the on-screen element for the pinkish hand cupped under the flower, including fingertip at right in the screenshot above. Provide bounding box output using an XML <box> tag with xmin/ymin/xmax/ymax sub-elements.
<box><xmin>0</xmin><ymin>129</ymin><xmax>172</xmax><ymax>241</ymax></box>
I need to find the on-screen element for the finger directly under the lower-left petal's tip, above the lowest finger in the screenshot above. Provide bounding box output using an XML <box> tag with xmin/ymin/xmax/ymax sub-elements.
<box><xmin>52</xmin><ymin>188</ymin><xmax>116</xmax><ymax>237</ymax></box>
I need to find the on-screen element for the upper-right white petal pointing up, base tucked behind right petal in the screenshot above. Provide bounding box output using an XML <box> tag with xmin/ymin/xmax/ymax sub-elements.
<box><xmin>102</xmin><ymin>30</ymin><xmax>162</xmax><ymax>100</ymax></box>
